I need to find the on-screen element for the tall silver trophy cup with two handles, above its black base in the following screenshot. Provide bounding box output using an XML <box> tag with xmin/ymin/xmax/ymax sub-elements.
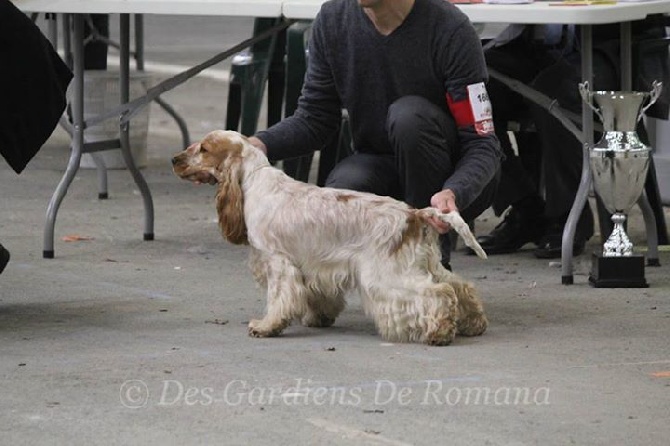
<box><xmin>579</xmin><ymin>82</ymin><xmax>662</xmax><ymax>284</ymax></box>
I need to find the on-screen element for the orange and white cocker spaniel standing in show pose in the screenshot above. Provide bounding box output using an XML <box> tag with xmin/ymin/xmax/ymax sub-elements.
<box><xmin>172</xmin><ymin>130</ymin><xmax>488</xmax><ymax>345</ymax></box>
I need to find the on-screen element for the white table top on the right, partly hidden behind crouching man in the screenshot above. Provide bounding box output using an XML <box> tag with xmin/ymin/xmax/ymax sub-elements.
<box><xmin>282</xmin><ymin>0</ymin><xmax>670</xmax><ymax>25</ymax></box>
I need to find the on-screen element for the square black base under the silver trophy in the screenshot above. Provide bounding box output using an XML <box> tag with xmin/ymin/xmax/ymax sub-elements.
<box><xmin>589</xmin><ymin>252</ymin><xmax>649</xmax><ymax>288</ymax></box>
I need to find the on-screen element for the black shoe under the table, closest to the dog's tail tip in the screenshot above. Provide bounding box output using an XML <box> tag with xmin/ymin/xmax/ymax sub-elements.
<box><xmin>477</xmin><ymin>207</ymin><xmax>545</xmax><ymax>254</ymax></box>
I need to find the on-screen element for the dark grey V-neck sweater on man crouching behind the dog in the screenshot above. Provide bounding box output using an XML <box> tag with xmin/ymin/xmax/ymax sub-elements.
<box><xmin>256</xmin><ymin>0</ymin><xmax>500</xmax><ymax>208</ymax></box>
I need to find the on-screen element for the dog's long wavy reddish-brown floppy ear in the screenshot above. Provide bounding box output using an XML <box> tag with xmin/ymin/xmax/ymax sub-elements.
<box><xmin>216</xmin><ymin>155</ymin><xmax>249</xmax><ymax>245</ymax></box>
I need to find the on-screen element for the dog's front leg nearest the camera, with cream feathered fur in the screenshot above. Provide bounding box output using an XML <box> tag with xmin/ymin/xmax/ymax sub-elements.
<box><xmin>249</xmin><ymin>256</ymin><xmax>307</xmax><ymax>338</ymax></box>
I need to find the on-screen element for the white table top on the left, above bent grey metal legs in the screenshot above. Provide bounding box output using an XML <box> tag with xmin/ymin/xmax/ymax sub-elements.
<box><xmin>12</xmin><ymin>0</ymin><xmax>283</xmax><ymax>17</ymax></box>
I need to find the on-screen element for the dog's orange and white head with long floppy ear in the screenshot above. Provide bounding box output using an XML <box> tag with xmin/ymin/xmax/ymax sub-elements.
<box><xmin>172</xmin><ymin>130</ymin><xmax>250</xmax><ymax>245</ymax></box>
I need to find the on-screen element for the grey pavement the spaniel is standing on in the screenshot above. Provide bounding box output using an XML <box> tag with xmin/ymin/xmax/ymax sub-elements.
<box><xmin>0</xmin><ymin>13</ymin><xmax>670</xmax><ymax>445</ymax></box>
